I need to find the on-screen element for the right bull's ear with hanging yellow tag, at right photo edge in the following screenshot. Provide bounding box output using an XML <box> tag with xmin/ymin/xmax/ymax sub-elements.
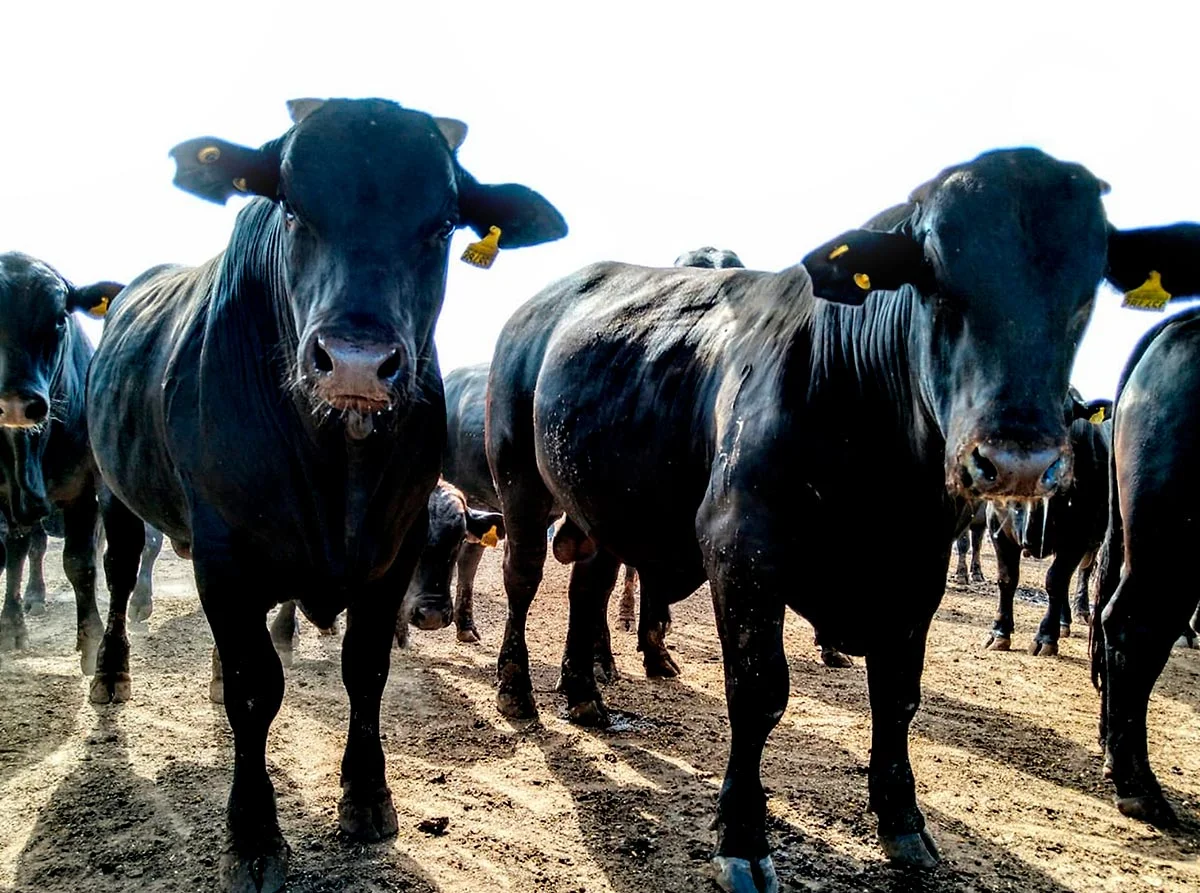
<box><xmin>1104</xmin><ymin>223</ymin><xmax>1200</xmax><ymax>310</ymax></box>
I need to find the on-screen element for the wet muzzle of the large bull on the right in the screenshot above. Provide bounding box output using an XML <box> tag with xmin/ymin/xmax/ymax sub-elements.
<box><xmin>953</xmin><ymin>440</ymin><xmax>1072</xmax><ymax>499</ymax></box>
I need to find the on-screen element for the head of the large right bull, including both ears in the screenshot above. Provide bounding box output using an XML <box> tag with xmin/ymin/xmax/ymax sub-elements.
<box><xmin>804</xmin><ymin>149</ymin><xmax>1200</xmax><ymax>498</ymax></box>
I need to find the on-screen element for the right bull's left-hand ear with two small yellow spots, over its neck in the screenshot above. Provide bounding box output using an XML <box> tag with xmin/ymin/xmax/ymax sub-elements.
<box><xmin>804</xmin><ymin>229</ymin><xmax>930</xmax><ymax>305</ymax></box>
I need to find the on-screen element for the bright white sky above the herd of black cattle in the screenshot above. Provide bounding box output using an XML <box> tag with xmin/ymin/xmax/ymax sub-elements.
<box><xmin>0</xmin><ymin>0</ymin><xmax>1200</xmax><ymax>397</ymax></box>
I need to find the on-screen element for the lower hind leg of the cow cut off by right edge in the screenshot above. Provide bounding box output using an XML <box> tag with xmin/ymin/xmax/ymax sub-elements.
<box><xmin>1099</xmin><ymin>562</ymin><xmax>1192</xmax><ymax>826</ymax></box>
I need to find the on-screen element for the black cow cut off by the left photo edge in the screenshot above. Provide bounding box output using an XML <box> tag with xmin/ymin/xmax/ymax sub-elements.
<box><xmin>0</xmin><ymin>252</ymin><xmax>121</xmax><ymax>676</ymax></box>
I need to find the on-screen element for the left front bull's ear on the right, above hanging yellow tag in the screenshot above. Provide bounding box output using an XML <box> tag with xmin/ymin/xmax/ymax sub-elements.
<box><xmin>458</xmin><ymin>168</ymin><xmax>566</xmax><ymax>248</ymax></box>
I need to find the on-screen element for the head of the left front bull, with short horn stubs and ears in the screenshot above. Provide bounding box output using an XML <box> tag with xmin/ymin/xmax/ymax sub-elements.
<box><xmin>172</xmin><ymin>100</ymin><xmax>566</xmax><ymax>431</ymax></box>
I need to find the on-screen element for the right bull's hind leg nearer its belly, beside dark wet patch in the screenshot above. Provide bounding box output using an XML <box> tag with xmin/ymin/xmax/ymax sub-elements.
<box><xmin>560</xmin><ymin>549</ymin><xmax>620</xmax><ymax>726</ymax></box>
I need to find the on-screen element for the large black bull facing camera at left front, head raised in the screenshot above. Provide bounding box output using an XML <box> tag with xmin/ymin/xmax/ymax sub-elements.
<box><xmin>88</xmin><ymin>100</ymin><xmax>566</xmax><ymax>891</ymax></box>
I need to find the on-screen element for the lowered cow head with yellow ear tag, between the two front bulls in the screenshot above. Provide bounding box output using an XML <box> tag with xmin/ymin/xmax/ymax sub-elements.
<box><xmin>401</xmin><ymin>480</ymin><xmax>504</xmax><ymax>629</ymax></box>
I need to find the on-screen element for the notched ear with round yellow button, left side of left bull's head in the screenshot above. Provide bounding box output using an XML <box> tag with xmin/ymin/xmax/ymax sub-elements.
<box><xmin>170</xmin><ymin>137</ymin><xmax>280</xmax><ymax>204</ymax></box>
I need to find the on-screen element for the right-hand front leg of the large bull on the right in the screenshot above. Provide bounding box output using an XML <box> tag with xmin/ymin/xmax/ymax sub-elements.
<box><xmin>866</xmin><ymin>621</ymin><xmax>940</xmax><ymax>868</ymax></box>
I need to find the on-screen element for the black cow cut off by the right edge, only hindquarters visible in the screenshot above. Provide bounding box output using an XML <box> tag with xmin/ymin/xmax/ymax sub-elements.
<box><xmin>1099</xmin><ymin>303</ymin><xmax>1200</xmax><ymax>825</ymax></box>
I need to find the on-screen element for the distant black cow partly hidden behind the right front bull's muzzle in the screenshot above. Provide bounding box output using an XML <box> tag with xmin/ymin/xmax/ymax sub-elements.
<box><xmin>986</xmin><ymin>418</ymin><xmax>1112</xmax><ymax>657</ymax></box>
